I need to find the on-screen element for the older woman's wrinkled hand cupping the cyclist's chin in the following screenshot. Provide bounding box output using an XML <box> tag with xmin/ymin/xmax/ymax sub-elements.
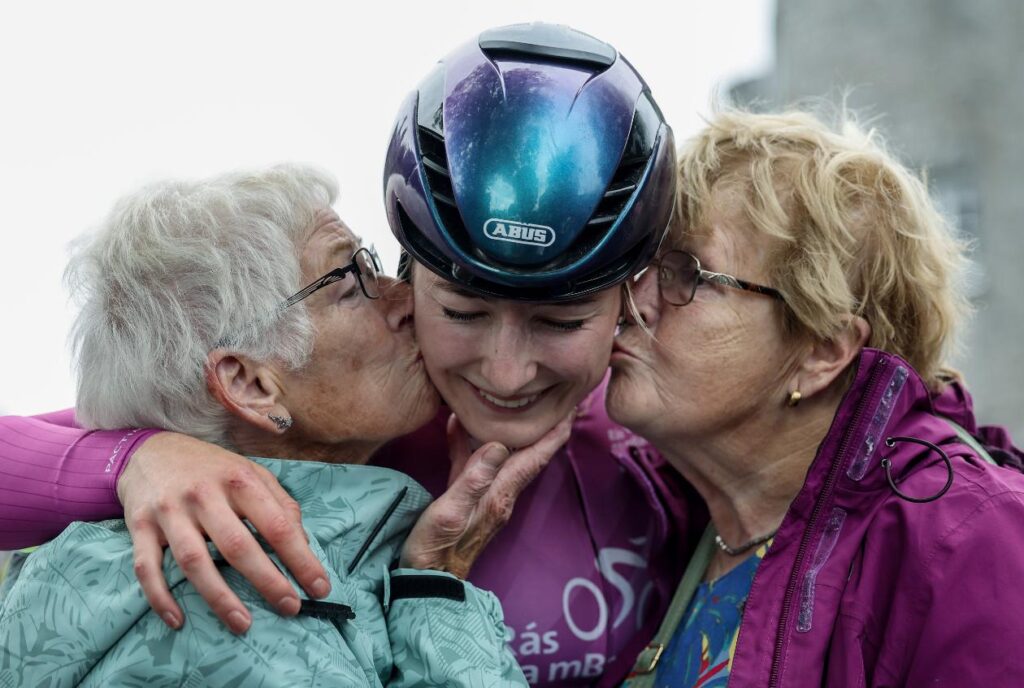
<box><xmin>400</xmin><ymin>413</ymin><xmax>575</xmax><ymax>578</ymax></box>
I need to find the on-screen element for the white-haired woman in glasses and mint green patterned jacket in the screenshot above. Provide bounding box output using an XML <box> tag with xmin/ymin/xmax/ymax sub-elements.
<box><xmin>0</xmin><ymin>166</ymin><xmax>568</xmax><ymax>686</ymax></box>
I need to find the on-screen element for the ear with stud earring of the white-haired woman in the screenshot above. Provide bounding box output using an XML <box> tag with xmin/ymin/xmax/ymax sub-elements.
<box><xmin>204</xmin><ymin>349</ymin><xmax>291</xmax><ymax>435</ymax></box>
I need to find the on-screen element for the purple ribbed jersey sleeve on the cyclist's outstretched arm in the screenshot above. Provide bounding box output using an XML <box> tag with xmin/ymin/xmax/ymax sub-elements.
<box><xmin>0</xmin><ymin>409</ymin><xmax>160</xmax><ymax>550</ymax></box>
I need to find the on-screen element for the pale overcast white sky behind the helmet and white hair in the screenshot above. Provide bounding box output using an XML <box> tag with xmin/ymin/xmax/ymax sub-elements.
<box><xmin>0</xmin><ymin>0</ymin><xmax>774</xmax><ymax>414</ymax></box>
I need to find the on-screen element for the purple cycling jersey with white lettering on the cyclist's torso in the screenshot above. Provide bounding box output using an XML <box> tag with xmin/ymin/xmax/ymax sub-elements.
<box><xmin>374</xmin><ymin>372</ymin><xmax>700</xmax><ymax>686</ymax></box>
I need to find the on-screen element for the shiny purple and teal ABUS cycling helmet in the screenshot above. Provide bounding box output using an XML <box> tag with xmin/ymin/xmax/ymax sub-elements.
<box><xmin>384</xmin><ymin>24</ymin><xmax>676</xmax><ymax>301</ymax></box>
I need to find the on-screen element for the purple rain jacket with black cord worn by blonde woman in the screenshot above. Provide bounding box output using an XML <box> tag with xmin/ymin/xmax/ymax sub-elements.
<box><xmin>729</xmin><ymin>349</ymin><xmax>1024</xmax><ymax>688</ymax></box>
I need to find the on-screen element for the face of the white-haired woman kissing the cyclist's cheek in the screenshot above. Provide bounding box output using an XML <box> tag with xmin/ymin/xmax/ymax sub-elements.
<box><xmin>282</xmin><ymin>211</ymin><xmax>438</xmax><ymax>456</ymax></box>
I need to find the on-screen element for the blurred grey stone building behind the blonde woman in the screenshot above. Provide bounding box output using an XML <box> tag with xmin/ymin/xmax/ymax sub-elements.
<box><xmin>730</xmin><ymin>0</ymin><xmax>1024</xmax><ymax>442</ymax></box>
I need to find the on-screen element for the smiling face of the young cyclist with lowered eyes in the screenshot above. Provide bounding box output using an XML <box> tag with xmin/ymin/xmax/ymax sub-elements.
<box><xmin>414</xmin><ymin>265</ymin><xmax>621</xmax><ymax>446</ymax></box>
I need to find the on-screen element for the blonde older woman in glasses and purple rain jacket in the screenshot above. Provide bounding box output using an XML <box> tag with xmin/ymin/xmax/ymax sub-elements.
<box><xmin>608</xmin><ymin>112</ymin><xmax>1024</xmax><ymax>688</ymax></box>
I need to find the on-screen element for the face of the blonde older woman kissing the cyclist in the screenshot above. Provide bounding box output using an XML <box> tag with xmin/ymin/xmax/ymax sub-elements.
<box><xmin>608</xmin><ymin>189</ymin><xmax>801</xmax><ymax>444</ymax></box>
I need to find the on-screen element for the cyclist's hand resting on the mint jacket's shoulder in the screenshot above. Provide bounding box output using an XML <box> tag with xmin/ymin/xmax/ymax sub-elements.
<box><xmin>117</xmin><ymin>432</ymin><xmax>331</xmax><ymax>633</ymax></box>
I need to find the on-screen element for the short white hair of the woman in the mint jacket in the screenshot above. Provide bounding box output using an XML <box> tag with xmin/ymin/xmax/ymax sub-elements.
<box><xmin>65</xmin><ymin>165</ymin><xmax>338</xmax><ymax>445</ymax></box>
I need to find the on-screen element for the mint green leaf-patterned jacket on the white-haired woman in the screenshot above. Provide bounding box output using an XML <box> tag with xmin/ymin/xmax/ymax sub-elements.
<box><xmin>0</xmin><ymin>459</ymin><xmax>526</xmax><ymax>688</ymax></box>
